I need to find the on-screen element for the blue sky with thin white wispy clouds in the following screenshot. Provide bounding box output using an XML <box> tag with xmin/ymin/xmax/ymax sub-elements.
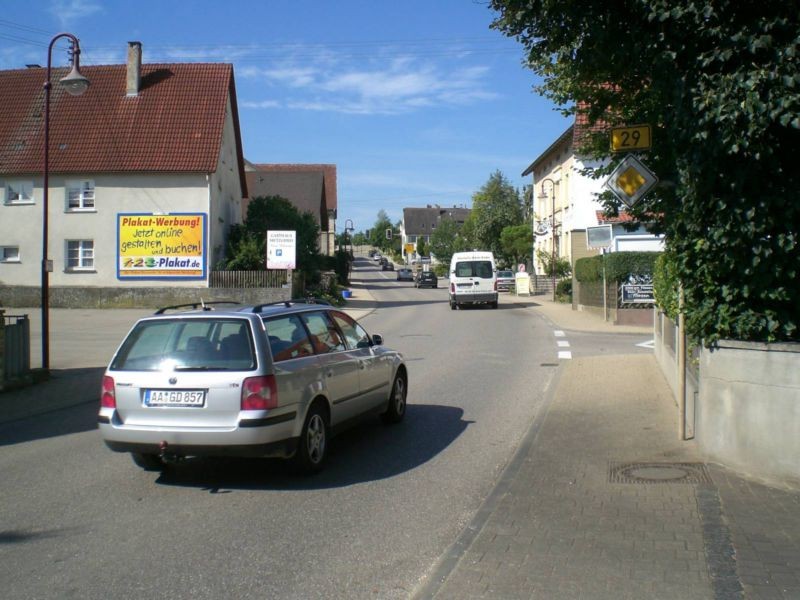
<box><xmin>0</xmin><ymin>0</ymin><xmax>570</xmax><ymax>231</ymax></box>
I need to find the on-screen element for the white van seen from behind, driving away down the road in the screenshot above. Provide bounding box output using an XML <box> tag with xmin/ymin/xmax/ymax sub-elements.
<box><xmin>450</xmin><ymin>252</ymin><xmax>497</xmax><ymax>310</ymax></box>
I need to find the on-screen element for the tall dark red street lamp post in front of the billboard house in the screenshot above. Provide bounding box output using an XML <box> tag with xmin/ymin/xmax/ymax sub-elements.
<box><xmin>41</xmin><ymin>33</ymin><xmax>89</xmax><ymax>370</ymax></box>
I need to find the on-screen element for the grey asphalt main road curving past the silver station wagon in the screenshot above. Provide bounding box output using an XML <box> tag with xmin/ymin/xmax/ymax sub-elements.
<box><xmin>0</xmin><ymin>259</ymin><xmax>641</xmax><ymax>598</ymax></box>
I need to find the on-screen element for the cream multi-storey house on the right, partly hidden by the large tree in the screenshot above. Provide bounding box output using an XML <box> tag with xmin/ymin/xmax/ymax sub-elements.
<box><xmin>522</xmin><ymin>113</ymin><xmax>663</xmax><ymax>274</ymax></box>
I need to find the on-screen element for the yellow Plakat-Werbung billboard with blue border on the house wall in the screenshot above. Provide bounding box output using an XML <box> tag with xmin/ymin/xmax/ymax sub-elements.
<box><xmin>117</xmin><ymin>213</ymin><xmax>206</xmax><ymax>280</ymax></box>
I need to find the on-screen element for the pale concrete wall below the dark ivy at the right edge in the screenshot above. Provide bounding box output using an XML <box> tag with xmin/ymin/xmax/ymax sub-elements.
<box><xmin>696</xmin><ymin>341</ymin><xmax>800</xmax><ymax>484</ymax></box>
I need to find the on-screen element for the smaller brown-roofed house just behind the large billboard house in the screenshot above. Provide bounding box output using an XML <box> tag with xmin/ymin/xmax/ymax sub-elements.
<box><xmin>243</xmin><ymin>162</ymin><xmax>338</xmax><ymax>256</ymax></box>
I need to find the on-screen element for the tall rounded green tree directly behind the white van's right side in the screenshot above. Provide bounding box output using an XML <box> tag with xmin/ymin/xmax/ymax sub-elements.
<box><xmin>467</xmin><ymin>171</ymin><xmax>522</xmax><ymax>256</ymax></box>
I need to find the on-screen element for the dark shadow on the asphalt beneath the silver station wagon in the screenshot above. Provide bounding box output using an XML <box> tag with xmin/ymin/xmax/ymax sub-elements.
<box><xmin>153</xmin><ymin>404</ymin><xmax>473</xmax><ymax>494</ymax></box>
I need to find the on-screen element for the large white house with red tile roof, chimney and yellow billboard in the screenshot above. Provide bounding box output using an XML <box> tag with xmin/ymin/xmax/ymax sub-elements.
<box><xmin>0</xmin><ymin>42</ymin><xmax>247</xmax><ymax>298</ymax></box>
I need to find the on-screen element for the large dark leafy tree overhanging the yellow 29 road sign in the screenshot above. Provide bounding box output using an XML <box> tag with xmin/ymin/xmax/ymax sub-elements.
<box><xmin>490</xmin><ymin>0</ymin><xmax>800</xmax><ymax>345</ymax></box>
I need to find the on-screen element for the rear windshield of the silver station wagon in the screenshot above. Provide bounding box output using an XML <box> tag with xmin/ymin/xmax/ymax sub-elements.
<box><xmin>110</xmin><ymin>319</ymin><xmax>255</xmax><ymax>371</ymax></box>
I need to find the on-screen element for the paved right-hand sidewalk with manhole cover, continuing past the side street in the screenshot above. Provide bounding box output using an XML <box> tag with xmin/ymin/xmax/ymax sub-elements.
<box><xmin>415</xmin><ymin>296</ymin><xmax>800</xmax><ymax>600</ymax></box>
